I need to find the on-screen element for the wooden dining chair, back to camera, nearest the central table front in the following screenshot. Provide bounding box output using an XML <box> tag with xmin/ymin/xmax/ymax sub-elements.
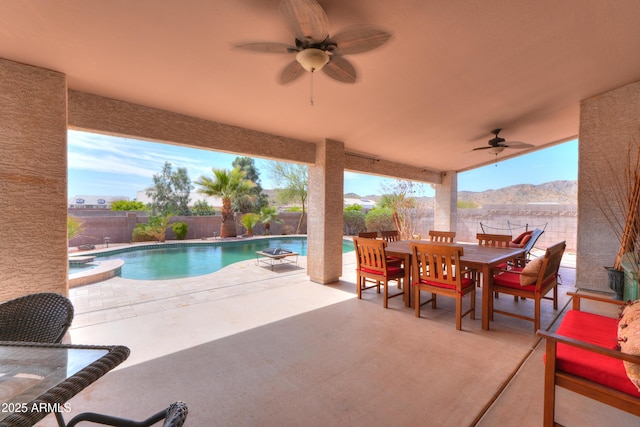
<box><xmin>411</xmin><ymin>243</ymin><xmax>476</xmax><ymax>330</ymax></box>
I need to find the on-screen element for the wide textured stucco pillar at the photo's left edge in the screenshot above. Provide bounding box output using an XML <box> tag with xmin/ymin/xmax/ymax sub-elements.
<box><xmin>0</xmin><ymin>59</ymin><xmax>68</xmax><ymax>301</ymax></box>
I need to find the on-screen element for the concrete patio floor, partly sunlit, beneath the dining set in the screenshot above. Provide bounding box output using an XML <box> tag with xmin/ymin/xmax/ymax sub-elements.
<box><xmin>38</xmin><ymin>249</ymin><xmax>640</xmax><ymax>427</ymax></box>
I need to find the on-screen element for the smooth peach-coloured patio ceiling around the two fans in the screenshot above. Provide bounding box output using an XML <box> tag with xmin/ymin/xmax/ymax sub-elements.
<box><xmin>0</xmin><ymin>0</ymin><xmax>640</xmax><ymax>171</ymax></box>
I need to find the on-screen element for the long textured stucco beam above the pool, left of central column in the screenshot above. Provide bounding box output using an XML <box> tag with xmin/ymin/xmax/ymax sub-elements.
<box><xmin>69</xmin><ymin>90</ymin><xmax>316</xmax><ymax>163</ymax></box>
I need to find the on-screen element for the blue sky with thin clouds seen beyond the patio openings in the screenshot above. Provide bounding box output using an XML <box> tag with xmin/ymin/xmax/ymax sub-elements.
<box><xmin>68</xmin><ymin>130</ymin><xmax>578</xmax><ymax>200</ymax></box>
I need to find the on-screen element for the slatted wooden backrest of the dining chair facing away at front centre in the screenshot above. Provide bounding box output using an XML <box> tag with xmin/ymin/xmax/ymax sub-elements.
<box><xmin>411</xmin><ymin>243</ymin><xmax>464</xmax><ymax>290</ymax></box>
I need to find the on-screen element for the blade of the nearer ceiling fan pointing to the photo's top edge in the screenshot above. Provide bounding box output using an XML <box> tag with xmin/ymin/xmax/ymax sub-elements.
<box><xmin>280</xmin><ymin>0</ymin><xmax>329</xmax><ymax>43</ymax></box>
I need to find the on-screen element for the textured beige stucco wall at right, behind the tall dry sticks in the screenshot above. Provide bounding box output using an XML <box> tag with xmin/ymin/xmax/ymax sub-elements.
<box><xmin>576</xmin><ymin>82</ymin><xmax>640</xmax><ymax>292</ymax></box>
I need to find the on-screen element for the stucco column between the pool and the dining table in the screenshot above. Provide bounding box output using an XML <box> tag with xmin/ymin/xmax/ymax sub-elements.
<box><xmin>307</xmin><ymin>139</ymin><xmax>344</xmax><ymax>284</ymax></box>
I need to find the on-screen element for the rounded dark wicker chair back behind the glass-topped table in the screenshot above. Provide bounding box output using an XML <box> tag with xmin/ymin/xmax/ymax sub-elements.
<box><xmin>0</xmin><ymin>292</ymin><xmax>73</xmax><ymax>344</ymax></box>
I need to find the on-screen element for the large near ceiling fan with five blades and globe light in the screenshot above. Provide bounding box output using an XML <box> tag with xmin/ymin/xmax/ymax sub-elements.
<box><xmin>235</xmin><ymin>0</ymin><xmax>391</xmax><ymax>87</ymax></box>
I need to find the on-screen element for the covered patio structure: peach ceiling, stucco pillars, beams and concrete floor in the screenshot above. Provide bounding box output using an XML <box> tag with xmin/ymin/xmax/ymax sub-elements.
<box><xmin>0</xmin><ymin>0</ymin><xmax>640</xmax><ymax>425</ymax></box>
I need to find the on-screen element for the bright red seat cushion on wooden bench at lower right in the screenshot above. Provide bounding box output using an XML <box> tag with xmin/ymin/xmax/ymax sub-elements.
<box><xmin>556</xmin><ymin>310</ymin><xmax>640</xmax><ymax>397</ymax></box>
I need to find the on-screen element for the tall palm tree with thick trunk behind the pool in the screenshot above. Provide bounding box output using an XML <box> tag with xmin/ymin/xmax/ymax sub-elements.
<box><xmin>196</xmin><ymin>168</ymin><xmax>255</xmax><ymax>237</ymax></box>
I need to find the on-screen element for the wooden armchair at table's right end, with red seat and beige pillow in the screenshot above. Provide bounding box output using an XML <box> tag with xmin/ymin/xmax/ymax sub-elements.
<box><xmin>488</xmin><ymin>241</ymin><xmax>566</xmax><ymax>332</ymax></box>
